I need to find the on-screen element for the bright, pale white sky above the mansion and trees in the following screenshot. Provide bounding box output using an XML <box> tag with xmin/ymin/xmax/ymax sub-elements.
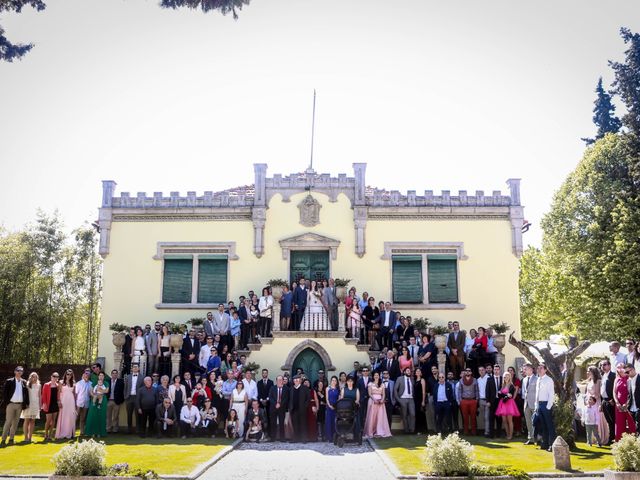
<box><xmin>0</xmin><ymin>0</ymin><xmax>640</xmax><ymax>248</ymax></box>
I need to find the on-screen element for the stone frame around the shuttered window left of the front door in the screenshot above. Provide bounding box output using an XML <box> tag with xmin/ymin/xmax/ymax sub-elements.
<box><xmin>153</xmin><ymin>242</ymin><xmax>240</xmax><ymax>310</ymax></box>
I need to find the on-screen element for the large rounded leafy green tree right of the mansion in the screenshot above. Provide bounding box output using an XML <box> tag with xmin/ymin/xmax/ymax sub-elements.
<box><xmin>520</xmin><ymin>134</ymin><xmax>640</xmax><ymax>340</ymax></box>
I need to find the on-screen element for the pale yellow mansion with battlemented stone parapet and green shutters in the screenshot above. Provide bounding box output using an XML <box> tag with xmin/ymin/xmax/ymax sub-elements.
<box><xmin>99</xmin><ymin>163</ymin><xmax>524</xmax><ymax>378</ymax></box>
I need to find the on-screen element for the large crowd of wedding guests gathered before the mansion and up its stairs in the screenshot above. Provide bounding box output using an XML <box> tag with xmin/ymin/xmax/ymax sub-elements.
<box><xmin>0</xmin><ymin>281</ymin><xmax>640</xmax><ymax>450</ymax></box>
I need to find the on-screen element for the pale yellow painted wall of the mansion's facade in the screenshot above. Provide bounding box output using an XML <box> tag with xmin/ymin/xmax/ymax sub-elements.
<box><xmin>99</xmin><ymin>193</ymin><xmax>520</xmax><ymax>370</ymax></box>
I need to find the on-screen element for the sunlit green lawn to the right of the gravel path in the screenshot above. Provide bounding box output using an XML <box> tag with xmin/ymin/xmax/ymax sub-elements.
<box><xmin>376</xmin><ymin>434</ymin><xmax>613</xmax><ymax>475</ymax></box>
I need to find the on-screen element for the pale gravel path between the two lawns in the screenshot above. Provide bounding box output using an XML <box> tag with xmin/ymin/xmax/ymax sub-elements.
<box><xmin>198</xmin><ymin>443</ymin><xmax>394</xmax><ymax>480</ymax></box>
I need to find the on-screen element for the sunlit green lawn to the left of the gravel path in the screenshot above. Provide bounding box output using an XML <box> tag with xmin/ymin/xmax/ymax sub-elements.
<box><xmin>0</xmin><ymin>434</ymin><xmax>232</xmax><ymax>475</ymax></box>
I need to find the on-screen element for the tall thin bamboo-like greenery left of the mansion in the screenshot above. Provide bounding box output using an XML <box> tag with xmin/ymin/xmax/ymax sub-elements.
<box><xmin>0</xmin><ymin>212</ymin><xmax>101</xmax><ymax>367</ymax></box>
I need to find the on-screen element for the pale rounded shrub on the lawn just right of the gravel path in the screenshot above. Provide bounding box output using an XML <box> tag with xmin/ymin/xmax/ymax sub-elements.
<box><xmin>425</xmin><ymin>433</ymin><xmax>473</xmax><ymax>476</ymax></box>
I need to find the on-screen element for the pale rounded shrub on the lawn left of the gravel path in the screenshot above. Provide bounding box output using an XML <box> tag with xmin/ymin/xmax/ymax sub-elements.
<box><xmin>53</xmin><ymin>440</ymin><xmax>105</xmax><ymax>477</ymax></box>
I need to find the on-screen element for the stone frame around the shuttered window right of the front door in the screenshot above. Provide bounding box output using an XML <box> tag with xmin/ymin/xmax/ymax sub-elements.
<box><xmin>380</xmin><ymin>242</ymin><xmax>469</xmax><ymax>310</ymax></box>
